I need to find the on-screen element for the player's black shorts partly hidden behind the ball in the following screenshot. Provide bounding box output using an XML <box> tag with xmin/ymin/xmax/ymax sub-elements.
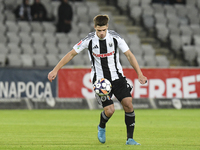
<box><xmin>97</xmin><ymin>77</ymin><xmax>132</xmax><ymax>107</ymax></box>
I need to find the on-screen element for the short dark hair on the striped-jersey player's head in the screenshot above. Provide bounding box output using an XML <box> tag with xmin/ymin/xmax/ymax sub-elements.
<box><xmin>93</xmin><ymin>15</ymin><xmax>109</xmax><ymax>27</ymax></box>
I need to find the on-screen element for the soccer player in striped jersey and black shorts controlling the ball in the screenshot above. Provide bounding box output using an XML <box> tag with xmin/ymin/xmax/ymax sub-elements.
<box><xmin>48</xmin><ymin>15</ymin><xmax>147</xmax><ymax>145</ymax></box>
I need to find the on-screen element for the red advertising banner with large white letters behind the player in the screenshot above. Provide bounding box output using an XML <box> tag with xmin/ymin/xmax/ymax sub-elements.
<box><xmin>58</xmin><ymin>68</ymin><xmax>200</xmax><ymax>98</ymax></box>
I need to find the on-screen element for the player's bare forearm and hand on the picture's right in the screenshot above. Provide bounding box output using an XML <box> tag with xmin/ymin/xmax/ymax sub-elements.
<box><xmin>124</xmin><ymin>50</ymin><xmax>147</xmax><ymax>84</ymax></box>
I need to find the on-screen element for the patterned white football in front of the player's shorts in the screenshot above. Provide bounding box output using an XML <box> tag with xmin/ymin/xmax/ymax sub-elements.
<box><xmin>93</xmin><ymin>78</ymin><xmax>112</xmax><ymax>96</ymax></box>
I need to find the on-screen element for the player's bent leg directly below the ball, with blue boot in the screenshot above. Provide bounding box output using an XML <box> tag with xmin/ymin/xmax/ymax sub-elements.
<box><xmin>96</xmin><ymin>96</ymin><xmax>115</xmax><ymax>143</ymax></box>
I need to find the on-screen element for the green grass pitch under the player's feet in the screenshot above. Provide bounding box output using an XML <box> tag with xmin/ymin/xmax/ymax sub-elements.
<box><xmin>0</xmin><ymin>109</ymin><xmax>200</xmax><ymax>150</ymax></box>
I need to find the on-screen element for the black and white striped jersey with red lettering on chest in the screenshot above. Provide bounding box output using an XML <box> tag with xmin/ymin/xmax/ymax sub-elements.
<box><xmin>73</xmin><ymin>30</ymin><xmax>129</xmax><ymax>82</ymax></box>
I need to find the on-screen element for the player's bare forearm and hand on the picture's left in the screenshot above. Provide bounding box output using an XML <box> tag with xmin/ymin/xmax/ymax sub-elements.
<box><xmin>48</xmin><ymin>49</ymin><xmax>78</xmax><ymax>82</ymax></box>
